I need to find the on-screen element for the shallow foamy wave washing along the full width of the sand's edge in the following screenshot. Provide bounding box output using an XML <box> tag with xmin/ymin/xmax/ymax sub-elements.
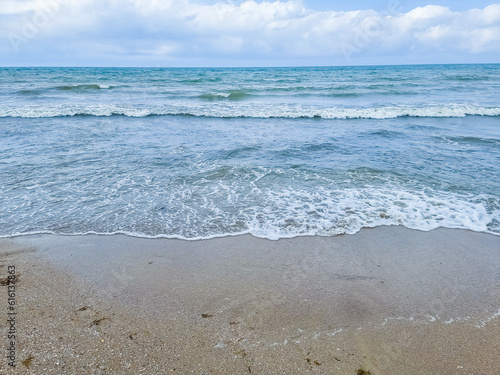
<box><xmin>0</xmin><ymin>188</ymin><xmax>500</xmax><ymax>240</ymax></box>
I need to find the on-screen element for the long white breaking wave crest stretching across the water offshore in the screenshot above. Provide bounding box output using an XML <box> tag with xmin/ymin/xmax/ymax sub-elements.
<box><xmin>0</xmin><ymin>103</ymin><xmax>500</xmax><ymax>119</ymax></box>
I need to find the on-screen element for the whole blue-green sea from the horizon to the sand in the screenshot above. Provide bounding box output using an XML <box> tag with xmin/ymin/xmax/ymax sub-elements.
<box><xmin>0</xmin><ymin>64</ymin><xmax>500</xmax><ymax>239</ymax></box>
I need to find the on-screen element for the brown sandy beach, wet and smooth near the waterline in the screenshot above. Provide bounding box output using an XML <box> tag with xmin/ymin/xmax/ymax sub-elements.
<box><xmin>0</xmin><ymin>227</ymin><xmax>500</xmax><ymax>375</ymax></box>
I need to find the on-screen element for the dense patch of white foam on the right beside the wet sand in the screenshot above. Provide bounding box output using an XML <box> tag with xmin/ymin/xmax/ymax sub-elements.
<box><xmin>237</xmin><ymin>188</ymin><xmax>500</xmax><ymax>240</ymax></box>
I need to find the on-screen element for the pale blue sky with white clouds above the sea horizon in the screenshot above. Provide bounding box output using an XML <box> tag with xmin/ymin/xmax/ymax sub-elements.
<box><xmin>0</xmin><ymin>0</ymin><xmax>500</xmax><ymax>66</ymax></box>
